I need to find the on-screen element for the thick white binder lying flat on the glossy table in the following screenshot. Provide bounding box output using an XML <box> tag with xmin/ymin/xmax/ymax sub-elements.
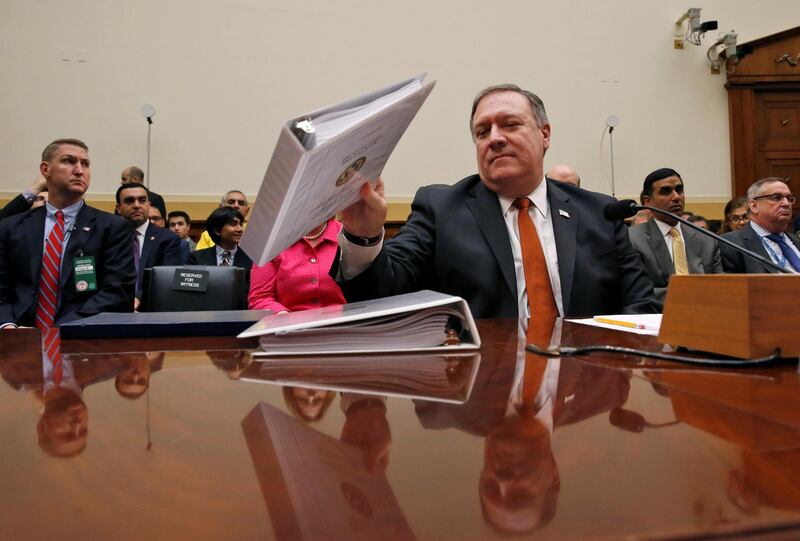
<box><xmin>234</xmin><ymin>290</ymin><xmax>481</xmax><ymax>357</ymax></box>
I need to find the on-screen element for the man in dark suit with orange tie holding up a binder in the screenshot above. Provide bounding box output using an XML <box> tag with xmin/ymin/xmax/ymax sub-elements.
<box><xmin>331</xmin><ymin>85</ymin><xmax>657</xmax><ymax>318</ymax></box>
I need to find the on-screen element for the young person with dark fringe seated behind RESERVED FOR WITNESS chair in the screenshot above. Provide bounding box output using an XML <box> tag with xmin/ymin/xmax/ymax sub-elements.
<box><xmin>188</xmin><ymin>207</ymin><xmax>253</xmax><ymax>299</ymax></box>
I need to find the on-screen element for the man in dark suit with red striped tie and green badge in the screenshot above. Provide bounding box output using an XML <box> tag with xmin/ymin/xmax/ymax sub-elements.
<box><xmin>0</xmin><ymin>139</ymin><xmax>135</xmax><ymax>327</ymax></box>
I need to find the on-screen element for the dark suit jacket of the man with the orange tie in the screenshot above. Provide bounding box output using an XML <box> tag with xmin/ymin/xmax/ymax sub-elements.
<box><xmin>331</xmin><ymin>175</ymin><xmax>658</xmax><ymax>318</ymax></box>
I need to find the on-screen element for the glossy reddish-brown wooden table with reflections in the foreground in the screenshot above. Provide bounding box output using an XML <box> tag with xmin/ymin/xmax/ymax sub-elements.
<box><xmin>0</xmin><ymin>321</ymin><xmax>800</xmax><ymax>540</ymax></box>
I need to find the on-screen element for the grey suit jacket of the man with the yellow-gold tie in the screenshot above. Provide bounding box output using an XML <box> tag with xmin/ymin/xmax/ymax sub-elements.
<box><xmin>628</xmin><ymin>219</ymin><xmax>722</xmax><ymax>305</ymax></box>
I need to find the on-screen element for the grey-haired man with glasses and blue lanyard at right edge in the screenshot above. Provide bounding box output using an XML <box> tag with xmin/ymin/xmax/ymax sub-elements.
<box><xmin>720</xmin><ymin>177</ymin><xmax>800</xmax><ymax>273</ymax></box>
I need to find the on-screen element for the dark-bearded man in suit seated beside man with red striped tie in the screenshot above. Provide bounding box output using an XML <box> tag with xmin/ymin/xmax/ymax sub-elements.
<box><xmin>116</xmin><ymin>184</ymin><xmax>183</xmax><ymax>310</ymax></box>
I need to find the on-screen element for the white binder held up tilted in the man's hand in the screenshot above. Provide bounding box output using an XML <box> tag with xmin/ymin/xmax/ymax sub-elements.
<box><xmin>241</xmin><ymin>74</ymin><xmax>435</xmax><ymax>265</ymax></box>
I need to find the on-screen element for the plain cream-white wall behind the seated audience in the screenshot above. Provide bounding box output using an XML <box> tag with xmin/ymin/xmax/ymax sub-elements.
<box><xmin>0</xmin><ymin>0</ymin><xmax>800</xmax><ymax>199</ymax></box>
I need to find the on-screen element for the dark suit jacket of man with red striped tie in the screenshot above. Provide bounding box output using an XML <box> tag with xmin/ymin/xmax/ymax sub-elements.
<box><xmin>0</xmin><ymin>204</ymin><xmax>136</xmax><ymax>325</ymax></box>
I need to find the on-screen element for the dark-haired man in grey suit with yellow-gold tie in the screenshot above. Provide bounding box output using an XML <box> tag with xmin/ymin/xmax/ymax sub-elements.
<box><xmin>628</xmin><ymin>168</ymin><xmax>722</xmax><ymax>305</ymax></box>
